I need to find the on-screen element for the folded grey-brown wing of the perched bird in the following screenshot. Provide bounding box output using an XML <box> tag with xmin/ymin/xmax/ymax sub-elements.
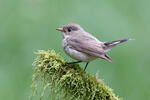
<box><xmin>67</xmin><ymin>36</ymin><xmax>112</xmax><ymax>62</ymax></box>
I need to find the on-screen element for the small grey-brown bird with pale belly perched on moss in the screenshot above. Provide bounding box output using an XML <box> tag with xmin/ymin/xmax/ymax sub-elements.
<box><xmin>56</xmin><ymin>24</ymin><xmax>132</xmax><ymax>71</ymax></box>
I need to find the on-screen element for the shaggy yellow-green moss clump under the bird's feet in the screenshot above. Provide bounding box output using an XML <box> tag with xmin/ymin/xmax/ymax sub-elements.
<box><xmin>31</xmin><ymin>50</ymin><xmax>120</xmax><ymax>100</ymax></box>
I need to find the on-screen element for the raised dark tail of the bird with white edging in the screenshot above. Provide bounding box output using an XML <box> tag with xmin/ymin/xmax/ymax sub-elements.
<box><xmin>104</xmin><ymin>39</ymin><xmax>133</xmax><ymax>51</ymax></box>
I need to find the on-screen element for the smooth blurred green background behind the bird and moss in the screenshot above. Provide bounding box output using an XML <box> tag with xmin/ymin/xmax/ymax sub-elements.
<box><xmin>0</xmin><ymin>0</ymin><xmax>150</xmax><ymax>100</ymax></box>
